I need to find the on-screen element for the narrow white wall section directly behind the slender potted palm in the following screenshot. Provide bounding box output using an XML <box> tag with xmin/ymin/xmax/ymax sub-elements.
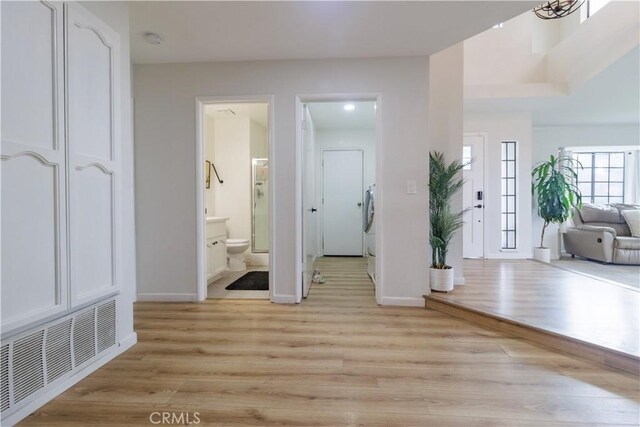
<box><xmin>430</xmin><ymin>43</ymin><xmax>464</xmax><ymax>285</ymax></box>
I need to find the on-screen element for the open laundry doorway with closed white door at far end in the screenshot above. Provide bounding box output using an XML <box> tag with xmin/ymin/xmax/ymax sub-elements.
<box><xmin>296</xmin><ymin>96</ymin><xmax>379</xmax><ymax>302</ymax></box>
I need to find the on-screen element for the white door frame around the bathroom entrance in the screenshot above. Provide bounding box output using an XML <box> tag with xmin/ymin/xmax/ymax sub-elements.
<box><xmin>195</xmin><ymin>95</ymin><xmax>277</xmax><ymax>301</ymax></box>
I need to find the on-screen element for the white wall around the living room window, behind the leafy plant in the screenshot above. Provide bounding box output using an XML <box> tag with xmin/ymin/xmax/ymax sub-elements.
<box><xmin>531</xmin><ymin>124</ymin><xmax>640</xmax><ymax>258</ymax></box>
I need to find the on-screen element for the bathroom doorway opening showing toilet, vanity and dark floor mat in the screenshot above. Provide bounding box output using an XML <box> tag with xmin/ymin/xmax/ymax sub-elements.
<box><xmin>196</xmin><ymin>97</ymin><xmax>273</xmax><ymax>301</ymax></box>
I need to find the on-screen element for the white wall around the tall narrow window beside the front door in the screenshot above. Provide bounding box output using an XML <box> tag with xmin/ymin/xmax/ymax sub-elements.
<box><xmin>464</xmin><ymin>113</ymin><xmax>538</xmax><ymax>258</ymax></box>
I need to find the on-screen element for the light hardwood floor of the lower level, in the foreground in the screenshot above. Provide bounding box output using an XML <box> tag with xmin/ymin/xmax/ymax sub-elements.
<box><xmin>24</xmin><ymin>258</ymin><xmax>640</xmax><ymax>427</ymax></box>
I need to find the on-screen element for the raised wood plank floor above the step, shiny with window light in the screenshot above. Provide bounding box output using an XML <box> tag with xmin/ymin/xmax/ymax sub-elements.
<box><xmin>430</xmin><ymin>260</ymin><xmax>640</xmax><ymax>359</ymax></box>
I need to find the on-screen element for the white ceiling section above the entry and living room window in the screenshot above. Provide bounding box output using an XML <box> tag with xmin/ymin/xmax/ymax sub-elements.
<box><xmin>465</xmin><ymin>48</ymin><xmax>640</xmax><ymax>127</ymax></box>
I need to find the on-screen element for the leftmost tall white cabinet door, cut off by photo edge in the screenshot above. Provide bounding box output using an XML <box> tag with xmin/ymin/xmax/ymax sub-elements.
<box><xmin>0</xmin><ymin>2</ymin><xmax>68</xmax><ymax>333</ymax></box>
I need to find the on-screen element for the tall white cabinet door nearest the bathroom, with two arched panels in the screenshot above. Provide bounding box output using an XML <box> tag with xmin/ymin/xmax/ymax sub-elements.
<box><xmin>65</xmin><ymin>3</ymin><xmax>121</xmax><ymax>306</ymax></box>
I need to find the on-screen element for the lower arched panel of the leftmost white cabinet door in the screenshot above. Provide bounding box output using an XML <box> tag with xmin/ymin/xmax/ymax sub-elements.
<box><xmin>2</xmin><ymin>155</ymin><xmax>62</xmax><ymax>329</ymax></box>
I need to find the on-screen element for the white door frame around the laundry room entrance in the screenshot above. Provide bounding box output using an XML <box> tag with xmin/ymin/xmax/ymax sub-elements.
<box><xmin>295</xmin><ymin>93</ymin><xmax>384</xmax><ymax>305</ymax></box>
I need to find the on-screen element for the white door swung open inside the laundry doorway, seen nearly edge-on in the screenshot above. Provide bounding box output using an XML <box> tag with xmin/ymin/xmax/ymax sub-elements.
<box><xmin>302</xmin><ymin>105</ymin><xmax>318</xmax><ymax>298</ymax></box>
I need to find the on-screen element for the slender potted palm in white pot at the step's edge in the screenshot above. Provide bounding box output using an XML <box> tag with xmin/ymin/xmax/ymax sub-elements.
<box><xmin>429</xmin><ymin>151</ymin><xmax>465</xmax><ymax>292</ymax></box>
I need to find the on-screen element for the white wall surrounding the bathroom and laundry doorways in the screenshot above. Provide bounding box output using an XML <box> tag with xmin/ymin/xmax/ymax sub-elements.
<box><xmin>134</xmin><ymin>58</ymin><xmax>429</xmax><ymax>305</ymax></box>
